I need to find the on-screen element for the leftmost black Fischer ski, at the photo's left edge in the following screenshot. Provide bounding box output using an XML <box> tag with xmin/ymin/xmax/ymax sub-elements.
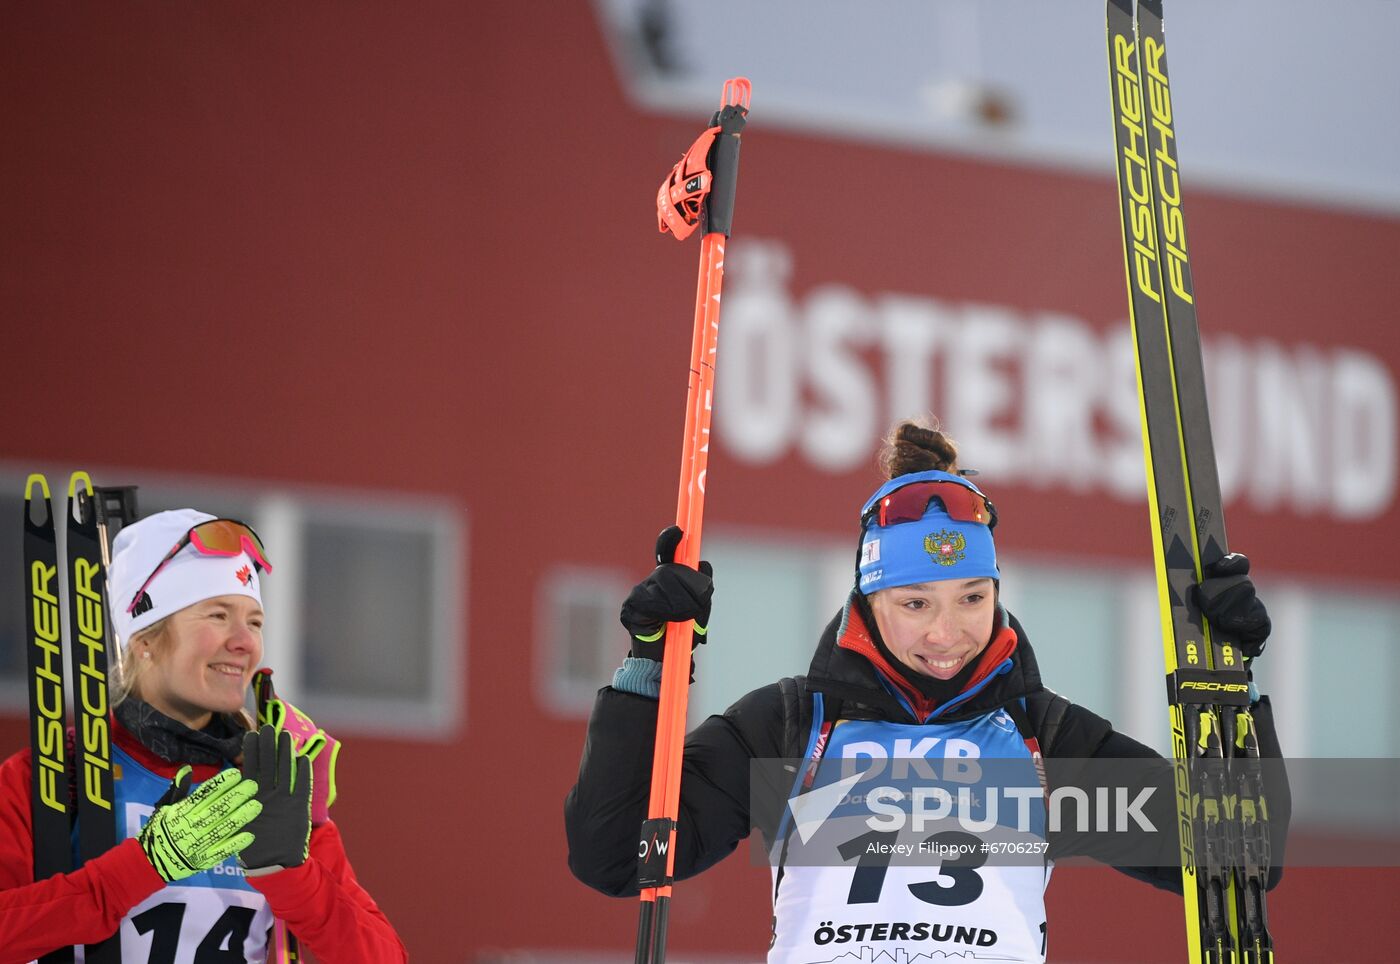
<box><xmin>22</xmin><ymin>474</ymin><xmax>73</xmax><ymax>964</ymax></box>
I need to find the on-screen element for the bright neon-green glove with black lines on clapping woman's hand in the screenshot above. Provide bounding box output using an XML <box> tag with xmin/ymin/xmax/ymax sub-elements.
<box><xmin>139</xmin><ymin>767</ymin><xmax>262</xmax><ymax>883</ymax></box>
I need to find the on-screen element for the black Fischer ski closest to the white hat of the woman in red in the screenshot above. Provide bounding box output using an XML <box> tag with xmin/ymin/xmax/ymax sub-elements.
<box><xmin>66</xmin><ymin>472</ymin><xmax>122</xmax><ymax>964</ymax></box>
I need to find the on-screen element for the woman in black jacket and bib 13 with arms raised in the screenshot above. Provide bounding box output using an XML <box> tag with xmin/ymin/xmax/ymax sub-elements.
<box><xmin>566</xmin><ymin>423</ymin><xmax>1288</xmax><ymax>963</ymax></box>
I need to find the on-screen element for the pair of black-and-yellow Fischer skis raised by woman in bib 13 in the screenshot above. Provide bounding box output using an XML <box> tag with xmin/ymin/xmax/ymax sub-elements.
<box><xmin>1107</xmin><ymin>0</ymin><xmax>1273</xmax><ymax>963</ymax></box>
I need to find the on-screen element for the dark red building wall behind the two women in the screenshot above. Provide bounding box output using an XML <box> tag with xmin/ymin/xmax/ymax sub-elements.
<box><xmin>0</xmin><ymin>3</ymin><xmax>1400</xmax><ymax>961</ymax></box>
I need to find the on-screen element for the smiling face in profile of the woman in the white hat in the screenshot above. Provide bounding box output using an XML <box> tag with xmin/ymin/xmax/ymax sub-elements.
<box><xmin>134</xmin><ymin>596</ymin><xmax>263</xmax><ymax>730</ymax></box>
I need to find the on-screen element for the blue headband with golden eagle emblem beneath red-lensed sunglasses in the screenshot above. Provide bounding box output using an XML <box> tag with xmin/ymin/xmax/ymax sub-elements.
<box><xmin>857</xmin><ymin>472</ymin><xmax>1001</xmax><ymax>596</ymax></box>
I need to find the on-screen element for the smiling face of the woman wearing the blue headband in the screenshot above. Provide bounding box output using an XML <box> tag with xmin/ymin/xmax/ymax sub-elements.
<box><xmin>869</xmin><ymin>579</ymin><xmax>997</xmax><ymax>680</ymax></box>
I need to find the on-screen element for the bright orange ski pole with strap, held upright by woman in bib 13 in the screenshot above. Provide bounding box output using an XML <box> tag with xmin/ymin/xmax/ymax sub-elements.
<box><xmin>636</xmin><ymin>77</ymin><xmax>752</xmax><ymax>964</ymax></box>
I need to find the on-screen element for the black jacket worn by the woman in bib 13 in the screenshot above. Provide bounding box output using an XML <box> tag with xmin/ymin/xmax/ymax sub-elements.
<box><xmin>564</xmin><ymin>602</ymin><xmax>1289</xmax><ymax>897</ymax></box>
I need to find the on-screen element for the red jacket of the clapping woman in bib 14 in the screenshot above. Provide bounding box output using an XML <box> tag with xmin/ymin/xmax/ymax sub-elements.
<box><xmin>0</xmin><ymin>721</ymin><xmax>409</xmax><ymax>964</ymax></box>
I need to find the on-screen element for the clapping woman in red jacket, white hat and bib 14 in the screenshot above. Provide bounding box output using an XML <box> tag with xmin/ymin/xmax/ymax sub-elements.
<box><xmin>0</xmin><ymin>509</ymin><xmax>407</xmax><ymax>964</ymax></box>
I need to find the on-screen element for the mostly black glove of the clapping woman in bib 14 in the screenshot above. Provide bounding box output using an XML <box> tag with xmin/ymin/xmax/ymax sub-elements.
<box><xmin>238</xmin><ymin>723</ymin><xmax>311</xmax><ymax>877</ymax></box>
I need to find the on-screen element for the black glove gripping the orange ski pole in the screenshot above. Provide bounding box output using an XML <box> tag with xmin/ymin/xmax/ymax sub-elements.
<box><xmin>622</xmin><ymin>526</ymin><xmax>714</xmax><ymax>663</ymax></box>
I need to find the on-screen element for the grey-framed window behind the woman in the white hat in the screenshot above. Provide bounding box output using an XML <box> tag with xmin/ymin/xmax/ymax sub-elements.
<box><xmin>0</xmin><ymin>466</ymin><xmax>466</xmax><ymax>739</ymax></box>
